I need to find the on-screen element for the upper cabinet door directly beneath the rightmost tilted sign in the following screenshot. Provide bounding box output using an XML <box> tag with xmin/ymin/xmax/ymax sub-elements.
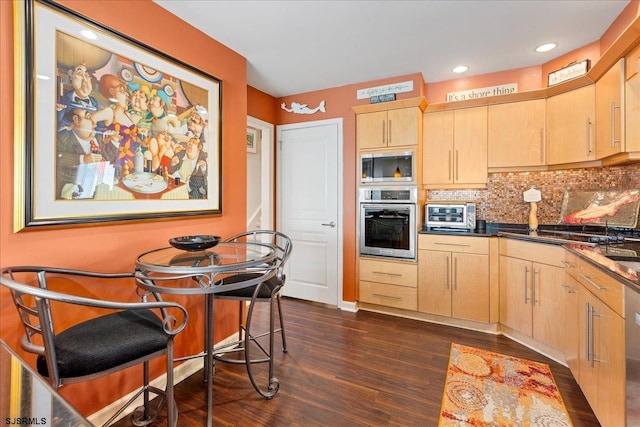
<box><xmin>547</xmin><ymin>85</ymin><xmax>596</xmax><ymax>165</ymax></box>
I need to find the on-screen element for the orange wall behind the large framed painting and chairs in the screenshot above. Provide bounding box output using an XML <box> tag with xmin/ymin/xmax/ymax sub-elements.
<box><xmin>0</xmin><ymin>0</ymin><xmax>247</xmax><ymax>415</ymax></box>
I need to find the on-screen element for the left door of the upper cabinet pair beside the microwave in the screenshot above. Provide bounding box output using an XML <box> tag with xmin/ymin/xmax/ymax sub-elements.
<box><xmin>422</xmin><ymin>110</ymin><xmax>453</xmax><ymax>184</ymax></box>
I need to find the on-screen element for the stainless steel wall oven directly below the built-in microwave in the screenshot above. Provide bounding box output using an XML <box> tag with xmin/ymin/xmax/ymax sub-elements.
<box><xmin>359</xmin><ymin>187</ymin><xmax>418</xmax><ymax>259</ymax></box>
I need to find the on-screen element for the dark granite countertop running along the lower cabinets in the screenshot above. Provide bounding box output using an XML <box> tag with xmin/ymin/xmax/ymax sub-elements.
<box><xmin>419</xmin><ymin>223</ymin><xmax>640</xmax><ymax>292</ymax></box>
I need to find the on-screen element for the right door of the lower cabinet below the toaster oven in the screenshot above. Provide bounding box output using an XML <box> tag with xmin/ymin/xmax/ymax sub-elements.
<box><xmin>451</xmin><ymin>253</ymin><xmax>489</xmax><ymax>323</ymax></box>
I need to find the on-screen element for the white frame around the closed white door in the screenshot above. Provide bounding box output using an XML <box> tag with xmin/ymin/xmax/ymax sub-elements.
<box><xmin>276</xmin><ymin>118</ymin><xmax>344</xmax><ymax>311</ymax></box>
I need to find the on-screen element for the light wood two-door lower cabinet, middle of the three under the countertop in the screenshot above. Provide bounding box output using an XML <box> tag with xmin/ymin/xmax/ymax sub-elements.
<box><xmin>500</xmin><ymin>239</ymin><xmax>565</xmax><ymax>351</ymax></box>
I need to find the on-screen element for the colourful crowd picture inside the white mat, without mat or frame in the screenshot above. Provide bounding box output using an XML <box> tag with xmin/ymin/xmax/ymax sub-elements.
<box><xmin>52</xmin><ymin>32</ymin><xmax>215</xmax><ymax>200</ymax></box>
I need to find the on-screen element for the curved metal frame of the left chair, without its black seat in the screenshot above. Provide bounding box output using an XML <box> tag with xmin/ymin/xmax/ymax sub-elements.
<box><xmin>0</xmin><ymin>266</ymin><xmax>188</xmax><ymax>427</ymax></box>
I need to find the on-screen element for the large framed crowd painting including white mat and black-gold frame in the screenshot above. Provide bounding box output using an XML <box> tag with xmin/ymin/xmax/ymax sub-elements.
<box><xmin>14</xmin><ymin>0</ymin><xmax>222</xmax><ymax>231</ymax></box>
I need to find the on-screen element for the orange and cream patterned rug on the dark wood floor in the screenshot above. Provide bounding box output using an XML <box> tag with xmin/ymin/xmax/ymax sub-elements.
<box><xmin>438</xmin><ymin>343</ymin><xmax>573</xmax><ymax>427</ymax></box>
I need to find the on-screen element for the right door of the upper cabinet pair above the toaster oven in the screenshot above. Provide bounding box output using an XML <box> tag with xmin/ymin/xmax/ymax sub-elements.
<box><xmin>453</xmin><ymin>107</ymin><xmax>488</xmax><ymax>184</ymax></box>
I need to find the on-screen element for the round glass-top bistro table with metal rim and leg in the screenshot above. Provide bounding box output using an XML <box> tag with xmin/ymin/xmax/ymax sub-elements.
<box><xmin>135</xmin><ymin>242</ymin><xmax>276</xmax><ymax>427</ymax></box>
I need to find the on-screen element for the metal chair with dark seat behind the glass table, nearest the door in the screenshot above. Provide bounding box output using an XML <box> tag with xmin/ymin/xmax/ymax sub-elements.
<box><xmin>215</xmin><ymin>230</ymin><xmax>293</xmax><ymax>399</ymax></box>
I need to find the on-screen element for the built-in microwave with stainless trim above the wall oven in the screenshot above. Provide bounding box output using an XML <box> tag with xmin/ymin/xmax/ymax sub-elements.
<box><xmin>360</xmin><ymin>150</ymin><xmax>416</xmax><ymax>185</ymax></box>
